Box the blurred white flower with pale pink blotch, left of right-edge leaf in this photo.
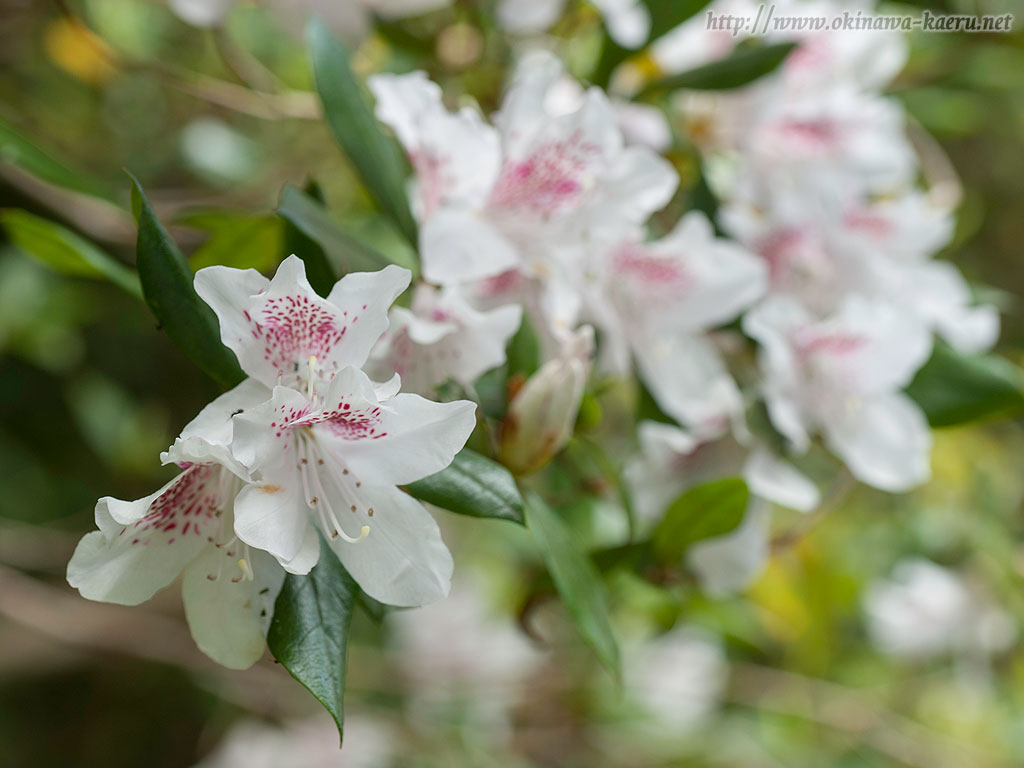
[743,296,932,492]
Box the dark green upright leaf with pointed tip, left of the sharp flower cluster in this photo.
[129,174,245,387]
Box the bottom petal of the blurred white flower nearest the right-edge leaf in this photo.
[824,393,932,493]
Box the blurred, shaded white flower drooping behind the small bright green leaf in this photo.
[626,422,819,596]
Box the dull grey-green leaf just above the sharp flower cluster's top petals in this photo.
[278,186,416,280]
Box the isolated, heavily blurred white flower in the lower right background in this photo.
[863,559,1017,658]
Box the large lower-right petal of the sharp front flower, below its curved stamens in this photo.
[330,485,455,606]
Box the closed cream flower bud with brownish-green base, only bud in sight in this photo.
[500,326,594,475]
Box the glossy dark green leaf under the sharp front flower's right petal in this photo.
[406,449,525,525]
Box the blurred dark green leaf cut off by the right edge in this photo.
[906,343,1024,427]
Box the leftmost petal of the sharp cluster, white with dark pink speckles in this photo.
[68,466,222,605]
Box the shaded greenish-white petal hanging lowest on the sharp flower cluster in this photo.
[181,546,285,670]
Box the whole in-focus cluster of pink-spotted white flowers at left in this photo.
[68,256,476,668]
